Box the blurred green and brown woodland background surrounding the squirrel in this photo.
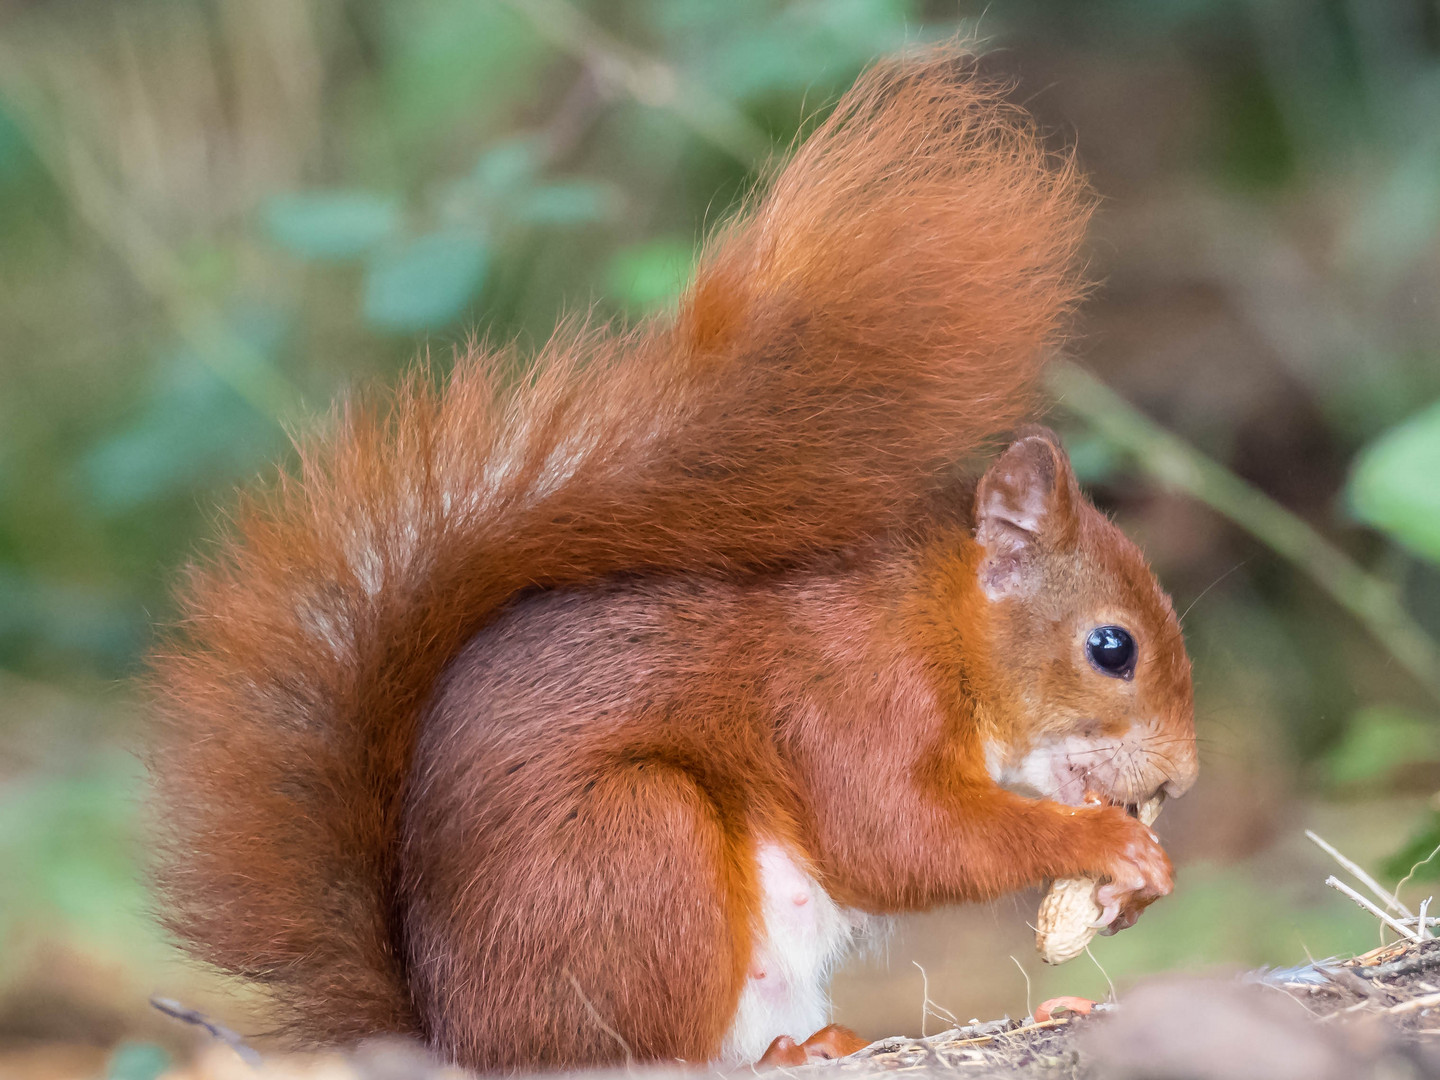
[0,0,1440,1080]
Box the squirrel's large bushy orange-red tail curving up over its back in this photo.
[151,46,1089,1041]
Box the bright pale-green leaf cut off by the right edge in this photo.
[1349,405,1440,562]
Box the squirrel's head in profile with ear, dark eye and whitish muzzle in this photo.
[966,428,1197,805]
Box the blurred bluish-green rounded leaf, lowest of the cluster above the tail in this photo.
[364,230,490,331]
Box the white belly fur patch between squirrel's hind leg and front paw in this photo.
[720,842,868,1066]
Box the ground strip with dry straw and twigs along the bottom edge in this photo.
[137,939,1440,1080]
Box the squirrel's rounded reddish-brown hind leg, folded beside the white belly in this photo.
[409,743,753,1071]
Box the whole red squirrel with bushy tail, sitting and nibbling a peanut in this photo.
[150,45,1195,1070]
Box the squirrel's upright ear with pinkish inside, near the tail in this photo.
[975,426,1081,600]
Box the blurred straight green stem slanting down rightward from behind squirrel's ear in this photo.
[1050,364,1440,700]
